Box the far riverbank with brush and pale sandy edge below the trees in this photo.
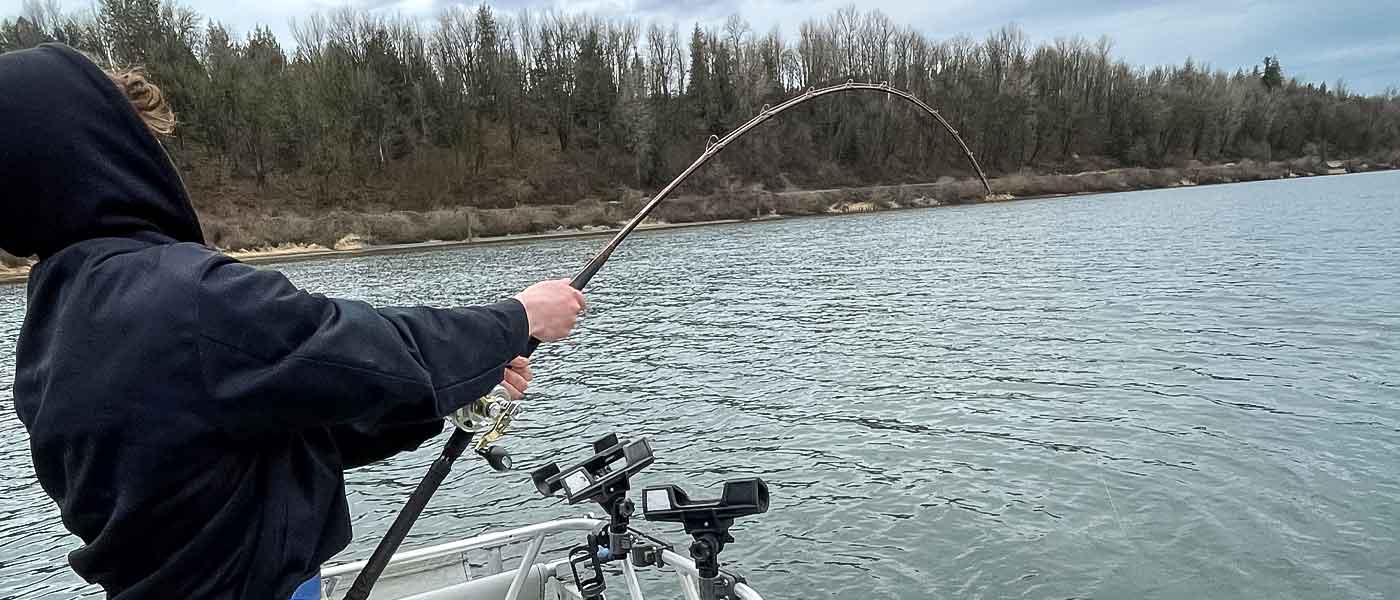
[0,161,1394,284]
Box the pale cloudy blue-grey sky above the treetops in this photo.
[10,0,1400,92]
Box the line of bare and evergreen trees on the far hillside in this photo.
[0,0,1400,210]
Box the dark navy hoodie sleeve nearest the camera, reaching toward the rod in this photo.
[196,256,529,433]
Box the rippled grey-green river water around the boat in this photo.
[0,173,1400,600]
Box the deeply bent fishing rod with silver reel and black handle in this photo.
[344,81,991,600]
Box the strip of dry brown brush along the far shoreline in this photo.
[49,154,1400,254]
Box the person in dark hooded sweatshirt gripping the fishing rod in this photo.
[0,45,582,599]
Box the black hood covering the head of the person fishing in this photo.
[0,43,204,259]
